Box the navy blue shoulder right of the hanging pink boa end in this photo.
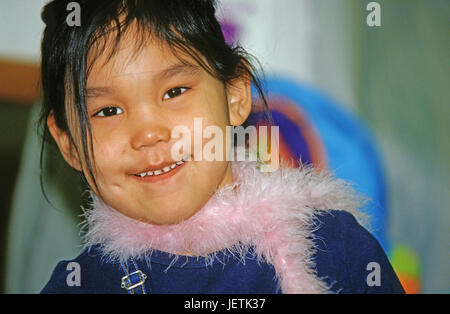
[313,210,404,293]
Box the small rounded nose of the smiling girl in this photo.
[130,115,171,150]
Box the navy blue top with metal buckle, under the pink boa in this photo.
[42,210,404,294]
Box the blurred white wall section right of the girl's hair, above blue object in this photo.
[221,0,358,108]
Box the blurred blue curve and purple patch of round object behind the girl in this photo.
[252,77,390,252]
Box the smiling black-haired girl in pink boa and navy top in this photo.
[41,0,403,294]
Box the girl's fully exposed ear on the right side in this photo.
[226,70,252,126]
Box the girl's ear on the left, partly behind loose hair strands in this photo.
[47,112,82,171]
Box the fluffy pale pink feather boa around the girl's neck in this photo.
[80,162,360,293]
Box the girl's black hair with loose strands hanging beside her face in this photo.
[39,0,271,195]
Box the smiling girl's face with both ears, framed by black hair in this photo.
[48,29,251,225]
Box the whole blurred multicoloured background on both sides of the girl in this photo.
[0,0,450,293]
